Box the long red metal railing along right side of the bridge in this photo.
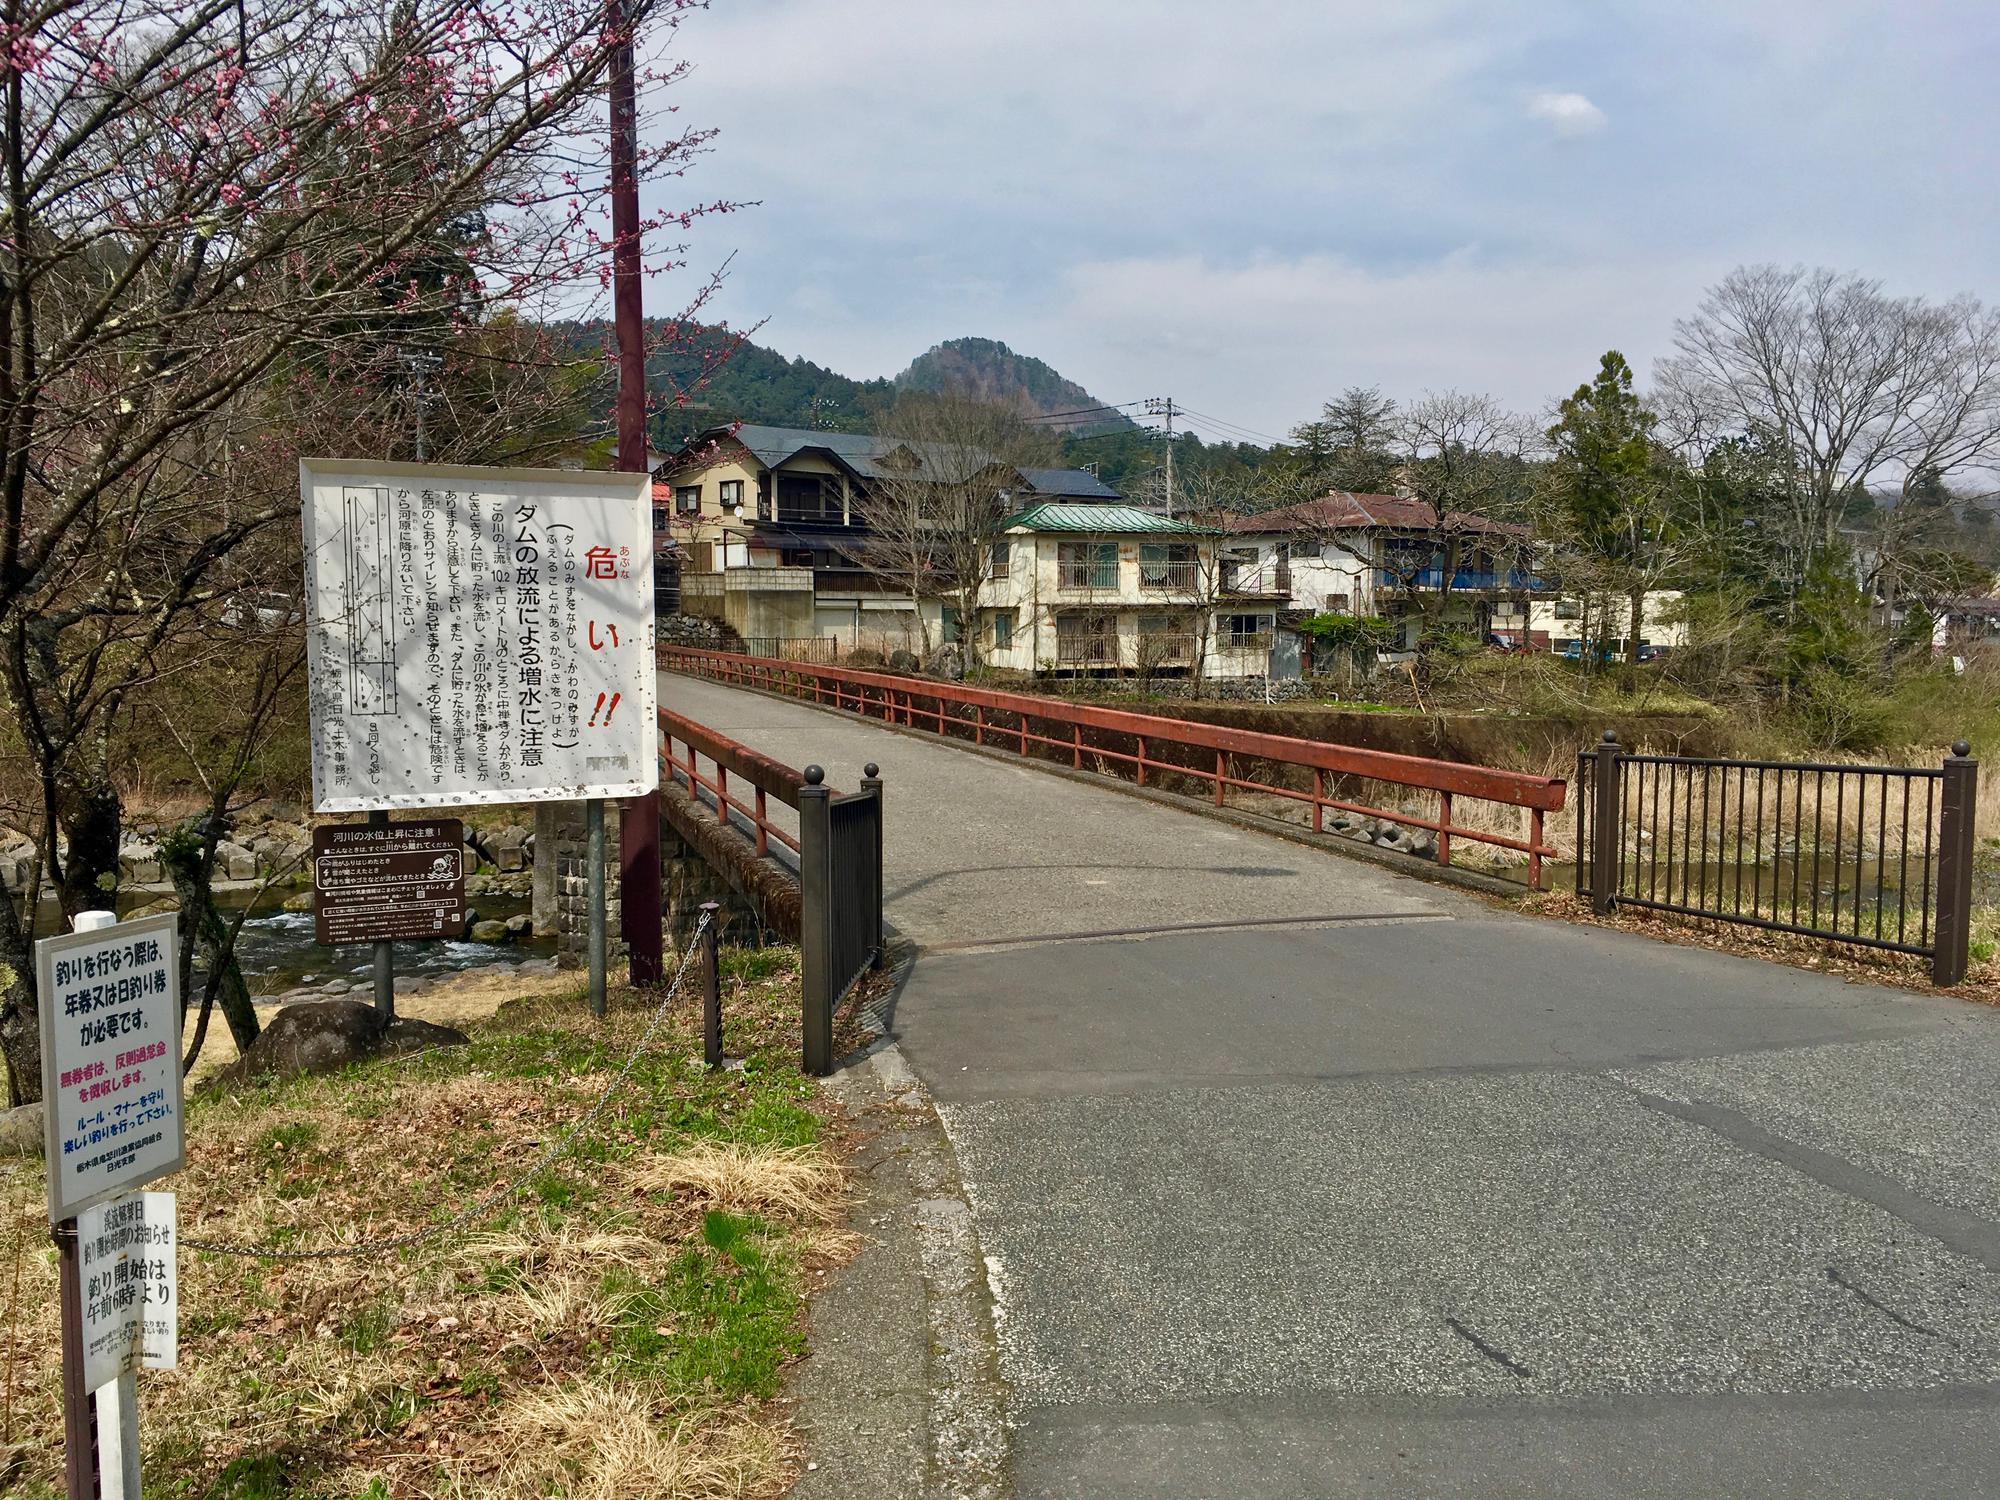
[660,646,1568,890]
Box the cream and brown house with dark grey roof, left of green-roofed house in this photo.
[654,422,1122,648]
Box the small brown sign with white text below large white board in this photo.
[312,818,466,944]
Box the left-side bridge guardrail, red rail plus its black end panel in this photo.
[660,708,882,1076]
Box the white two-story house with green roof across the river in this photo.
[972,500,1284,678]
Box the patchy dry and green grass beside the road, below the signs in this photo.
[0,948,846,1500]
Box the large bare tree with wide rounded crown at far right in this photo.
[1658,266,2000,594]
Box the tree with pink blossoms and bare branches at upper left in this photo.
[0,0,734,1100]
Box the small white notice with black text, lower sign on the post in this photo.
[76,1192,180,1390]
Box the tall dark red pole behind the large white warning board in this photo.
[608,0,664,984]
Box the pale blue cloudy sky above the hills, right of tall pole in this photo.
[650,0,2000,444]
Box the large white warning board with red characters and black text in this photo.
[298,458,658,812]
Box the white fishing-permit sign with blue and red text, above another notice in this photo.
[34,914,188,1224]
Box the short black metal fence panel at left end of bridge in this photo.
[798,766,882,1074]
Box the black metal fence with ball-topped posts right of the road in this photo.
[1576,730,1978,984]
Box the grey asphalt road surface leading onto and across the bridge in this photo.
[660,674,2000,1500]
